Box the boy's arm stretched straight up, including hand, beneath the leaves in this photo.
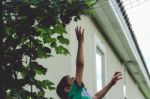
[75,27,84,86]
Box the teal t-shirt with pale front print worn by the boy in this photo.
[68,81,92,99]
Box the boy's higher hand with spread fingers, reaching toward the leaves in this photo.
[75,26,84,42]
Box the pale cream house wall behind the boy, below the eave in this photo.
[39,16,144,99]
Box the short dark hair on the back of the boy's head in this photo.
[56,75,68,99]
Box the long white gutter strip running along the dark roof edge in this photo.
[110,0,150,87]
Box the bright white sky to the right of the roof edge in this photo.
[123,0,150,73]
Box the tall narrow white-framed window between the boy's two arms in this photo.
[95,35,105,91]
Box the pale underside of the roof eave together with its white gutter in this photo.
[95,0,150,99]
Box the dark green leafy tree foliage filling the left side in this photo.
[0,0,93,99]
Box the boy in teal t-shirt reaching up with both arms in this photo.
[56,27,122,99]
